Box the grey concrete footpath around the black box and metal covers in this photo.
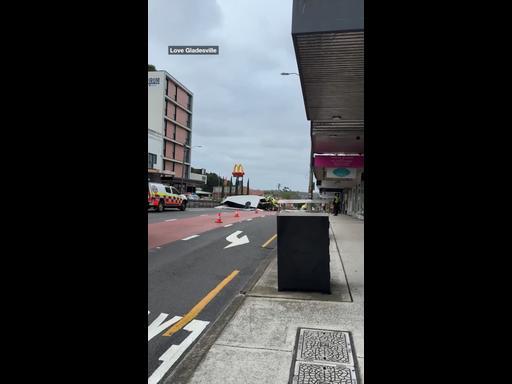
[189,216,364,384]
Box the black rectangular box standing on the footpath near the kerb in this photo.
[277,212,331,293]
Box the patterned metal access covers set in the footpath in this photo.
[290,328,357,384]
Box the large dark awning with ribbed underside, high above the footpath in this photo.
[292,0,364,186]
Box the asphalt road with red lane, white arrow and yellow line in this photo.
[148,208,276,384]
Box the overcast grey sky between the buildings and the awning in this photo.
[148,0,310,191]
